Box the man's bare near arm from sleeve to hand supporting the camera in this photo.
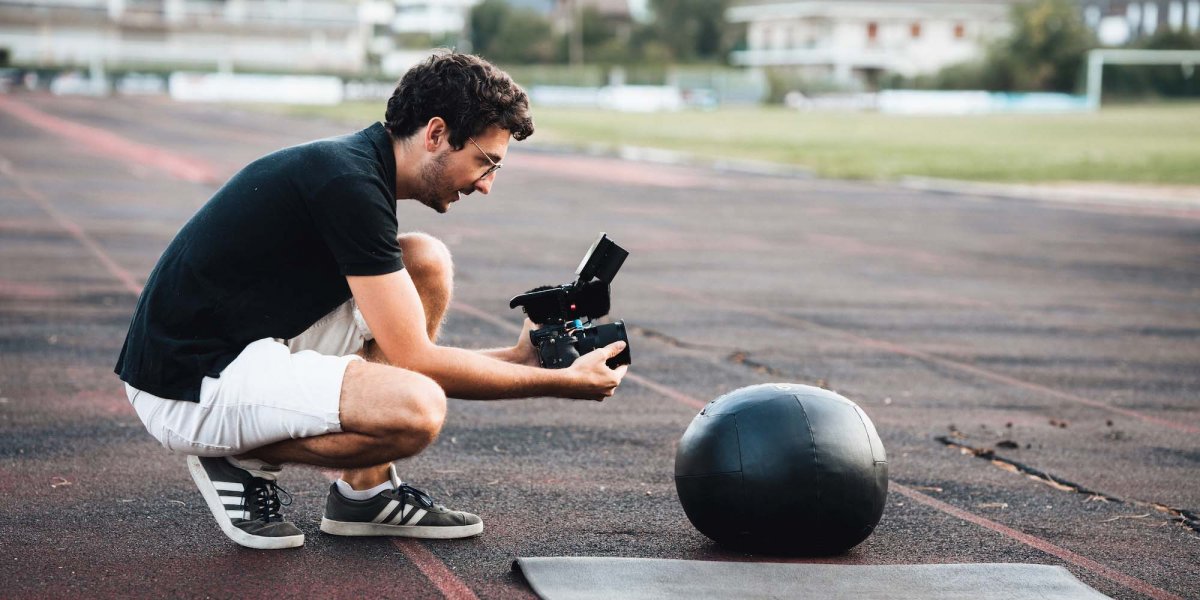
[347,270,628,400]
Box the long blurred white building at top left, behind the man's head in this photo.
[0,0,479,74]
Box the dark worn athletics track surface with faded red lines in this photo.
[0,94,1200,599]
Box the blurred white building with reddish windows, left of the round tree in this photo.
[726,0,1015,85]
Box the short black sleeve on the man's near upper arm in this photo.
[310,174,404,275]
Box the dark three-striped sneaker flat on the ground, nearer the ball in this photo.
[320,467,484,540]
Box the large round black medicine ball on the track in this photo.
[674,384,888,554]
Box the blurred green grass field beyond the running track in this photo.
[270,102,1200,185]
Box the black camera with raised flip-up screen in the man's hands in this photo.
[509,233,630,368]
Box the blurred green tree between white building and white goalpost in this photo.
[979,0,1096,92]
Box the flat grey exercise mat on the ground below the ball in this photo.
[512,557,1109,600]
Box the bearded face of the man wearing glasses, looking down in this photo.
[415,127,510,212]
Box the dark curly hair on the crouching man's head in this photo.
[384,50,533,150]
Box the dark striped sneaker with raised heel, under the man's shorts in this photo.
[187,456,304,550]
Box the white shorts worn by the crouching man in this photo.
[125,300,372,456]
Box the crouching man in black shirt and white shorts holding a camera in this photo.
[115,53,626,548]
